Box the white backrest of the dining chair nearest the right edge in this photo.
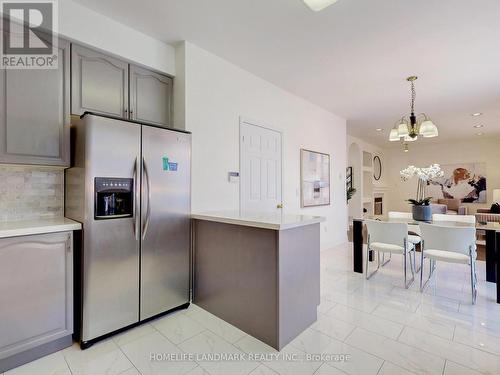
[420,223,476,255]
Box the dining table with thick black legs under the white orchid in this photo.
[352,216,500,304]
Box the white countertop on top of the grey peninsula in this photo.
[191,211,325,230]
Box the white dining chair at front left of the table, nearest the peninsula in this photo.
[365,220,416,289]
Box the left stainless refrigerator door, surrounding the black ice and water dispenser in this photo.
[81,115,141,342]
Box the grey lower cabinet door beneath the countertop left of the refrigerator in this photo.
[0,232,73,360]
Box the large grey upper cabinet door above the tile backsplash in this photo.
[0,36,70,166]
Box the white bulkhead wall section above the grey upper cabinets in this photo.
[58,0,175,75]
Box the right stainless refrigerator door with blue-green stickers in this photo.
[140,126,191,320]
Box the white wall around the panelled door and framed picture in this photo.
[183,43,347,248]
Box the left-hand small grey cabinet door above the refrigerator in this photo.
[71,44,128,118]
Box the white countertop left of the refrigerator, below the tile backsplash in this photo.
[0,217,82,238]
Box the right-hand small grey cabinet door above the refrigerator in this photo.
[130,65,172,127]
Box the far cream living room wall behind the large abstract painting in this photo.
[386,138,500,213]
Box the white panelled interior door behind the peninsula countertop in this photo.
[240,121,282,212]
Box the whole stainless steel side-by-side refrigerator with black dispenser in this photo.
[65,113,191,347]
